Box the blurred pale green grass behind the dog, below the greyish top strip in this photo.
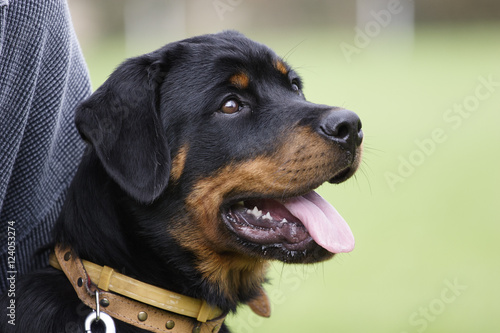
[80,24,500,333]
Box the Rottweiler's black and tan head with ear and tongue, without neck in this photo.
[76,32,363,298]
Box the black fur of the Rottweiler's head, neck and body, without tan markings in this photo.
[0,32,366,333]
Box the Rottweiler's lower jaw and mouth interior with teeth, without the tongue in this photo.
[221,198,334,263]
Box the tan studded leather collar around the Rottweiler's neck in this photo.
[50,244,225,333]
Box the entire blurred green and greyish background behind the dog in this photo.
[69,0,500,333]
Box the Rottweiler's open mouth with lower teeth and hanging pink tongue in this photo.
[222,191,354,253]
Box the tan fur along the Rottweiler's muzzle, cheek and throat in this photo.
[174,127,358,297]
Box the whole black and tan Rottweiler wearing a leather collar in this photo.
[0,31,363,333]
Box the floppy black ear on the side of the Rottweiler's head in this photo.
[75,54,171,203]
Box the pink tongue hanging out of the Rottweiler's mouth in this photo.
[282,191,354,253]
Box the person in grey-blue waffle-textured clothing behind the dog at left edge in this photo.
[0,0,91,294]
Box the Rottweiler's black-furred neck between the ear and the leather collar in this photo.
[55,153,260,311]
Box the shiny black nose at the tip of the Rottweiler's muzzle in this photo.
[319,109,363,150]
